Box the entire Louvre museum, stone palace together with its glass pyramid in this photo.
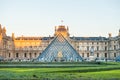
[0,25,120,62]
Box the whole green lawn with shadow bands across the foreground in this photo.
[0,63,120,80]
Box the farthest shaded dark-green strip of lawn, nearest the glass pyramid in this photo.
[0,62,120,68]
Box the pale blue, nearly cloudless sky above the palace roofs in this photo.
[0,0,120,37]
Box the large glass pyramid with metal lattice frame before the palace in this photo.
[37,34,83,62]
